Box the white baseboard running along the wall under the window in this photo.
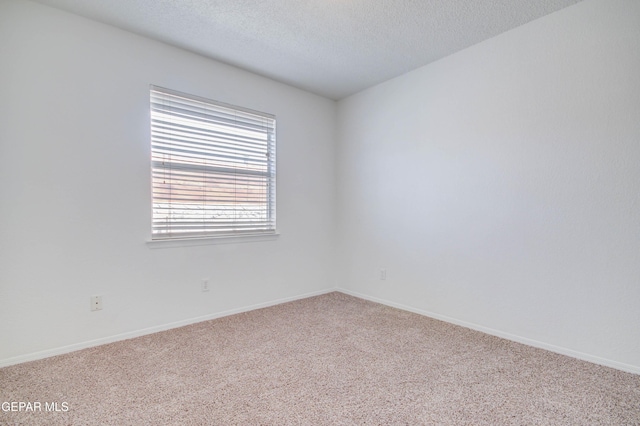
[0,288,338,368]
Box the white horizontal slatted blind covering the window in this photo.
[151,86,276,239]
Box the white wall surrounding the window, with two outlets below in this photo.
[0,0,335,364]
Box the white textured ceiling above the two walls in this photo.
[38,0,581,99]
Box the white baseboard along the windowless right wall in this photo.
[337,288,640,374]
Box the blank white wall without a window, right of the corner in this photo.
[338,0,640,372]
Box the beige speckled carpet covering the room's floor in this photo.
[0,293,640,425]
